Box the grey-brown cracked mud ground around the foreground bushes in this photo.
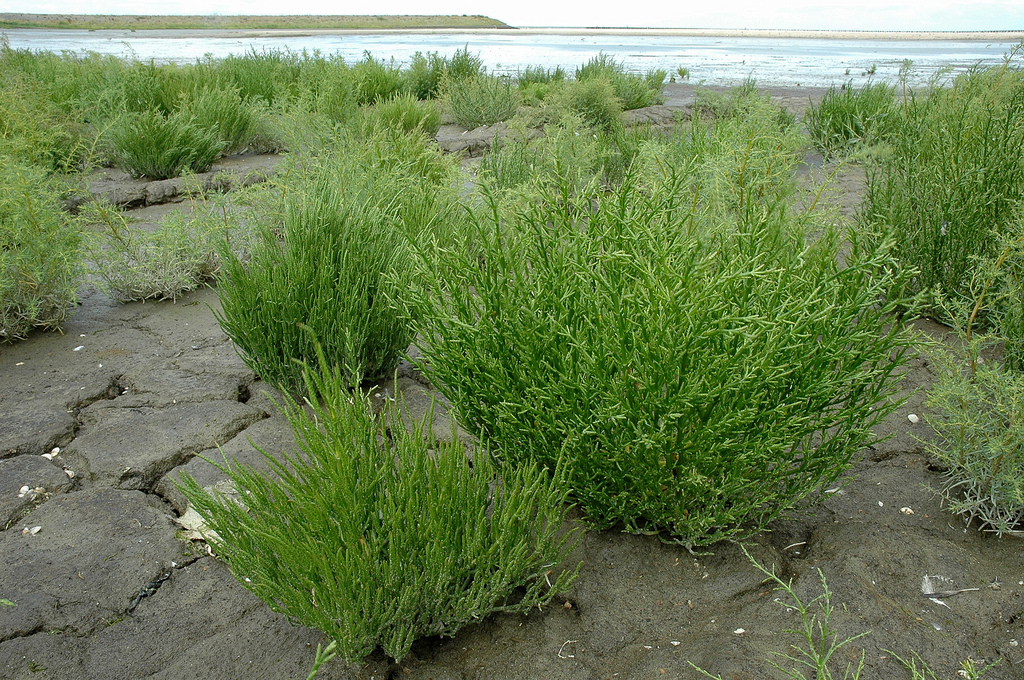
[0,100,1024,680]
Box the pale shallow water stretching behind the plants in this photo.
[4,29,1016,87]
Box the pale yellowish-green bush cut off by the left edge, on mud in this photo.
[0,154,81,342]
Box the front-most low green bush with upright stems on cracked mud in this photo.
[176,353,578,662]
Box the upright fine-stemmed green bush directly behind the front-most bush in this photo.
[217,151,417,388]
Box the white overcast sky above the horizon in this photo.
[0,0,1024,31]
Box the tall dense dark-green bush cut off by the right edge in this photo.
[861,51,1024,321]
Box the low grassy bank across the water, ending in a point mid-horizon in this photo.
[0,13,512,30]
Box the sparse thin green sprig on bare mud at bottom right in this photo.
[690,548,867,680]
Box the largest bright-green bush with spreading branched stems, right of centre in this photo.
[414,99,909,545]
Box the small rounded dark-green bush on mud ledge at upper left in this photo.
[109,110,223,179]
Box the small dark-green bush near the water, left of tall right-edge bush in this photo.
[805,83,899,157]
